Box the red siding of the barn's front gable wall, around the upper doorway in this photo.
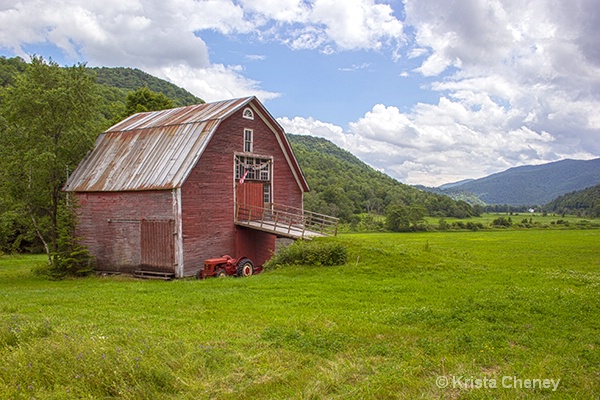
[181,103,302,275]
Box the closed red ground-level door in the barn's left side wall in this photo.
[141,220,175,272]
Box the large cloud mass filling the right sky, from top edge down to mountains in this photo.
[281,0,600,185]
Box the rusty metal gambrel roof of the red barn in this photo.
[64,96,309,192]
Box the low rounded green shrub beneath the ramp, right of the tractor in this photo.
[264,240,348,269]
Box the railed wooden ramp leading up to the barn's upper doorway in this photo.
[235,204,339,240]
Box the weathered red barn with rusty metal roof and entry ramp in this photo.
[64,97,337,277]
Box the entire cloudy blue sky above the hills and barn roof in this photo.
[0,0,600,186]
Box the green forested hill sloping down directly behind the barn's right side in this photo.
[287,134,474,220]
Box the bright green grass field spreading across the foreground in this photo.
[0,230,600,399]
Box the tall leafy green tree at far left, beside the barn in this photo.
[0,57,102,264]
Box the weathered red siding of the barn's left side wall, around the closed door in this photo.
[77,190,175,272]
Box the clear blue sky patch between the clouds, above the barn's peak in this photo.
[202,27,439,126]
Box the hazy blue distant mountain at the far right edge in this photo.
[437,158,600,206]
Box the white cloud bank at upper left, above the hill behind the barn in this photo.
[0,0,264,101]
